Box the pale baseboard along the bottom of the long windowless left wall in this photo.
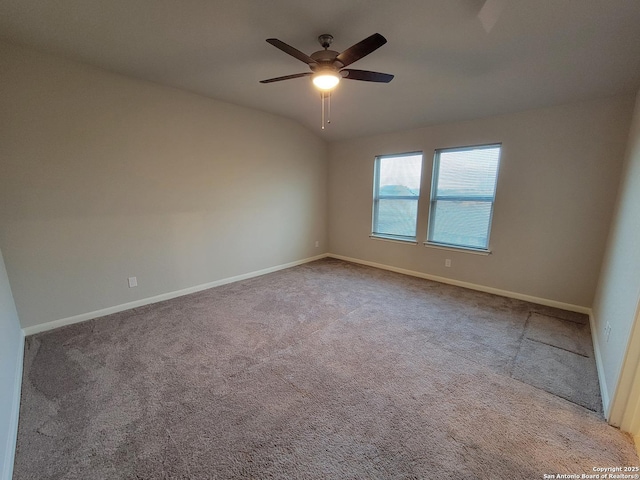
[23,254,327,335]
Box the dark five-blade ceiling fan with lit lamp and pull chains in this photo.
[260,33,393,129]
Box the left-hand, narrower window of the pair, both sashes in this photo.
[372,153,422,242]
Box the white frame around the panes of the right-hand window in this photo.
[424,142,502,255]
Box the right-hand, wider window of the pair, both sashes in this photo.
[427,145,501,251]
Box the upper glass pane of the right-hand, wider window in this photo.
[436,146,500,197]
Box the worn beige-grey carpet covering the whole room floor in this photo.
[14,259,639,479]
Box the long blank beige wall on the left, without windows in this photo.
[0,44,327,327]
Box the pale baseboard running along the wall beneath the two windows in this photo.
[327,253,591,315]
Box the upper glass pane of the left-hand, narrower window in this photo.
[378,155,422,197]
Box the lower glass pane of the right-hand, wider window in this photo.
[429,200,492,248]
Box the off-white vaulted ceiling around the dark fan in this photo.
[0,0,640,140]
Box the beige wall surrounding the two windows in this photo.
[329,96,633,307]
